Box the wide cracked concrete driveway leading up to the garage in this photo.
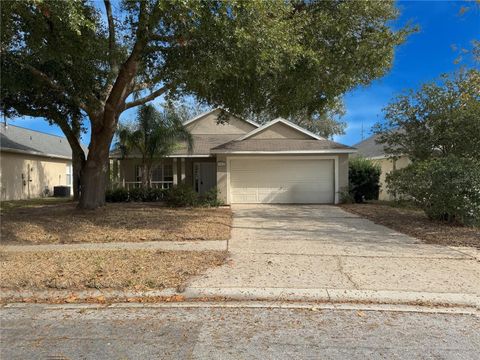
[189,205,480,303]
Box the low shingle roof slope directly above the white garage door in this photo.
[212,139,355,154]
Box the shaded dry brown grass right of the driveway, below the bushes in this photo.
[342,204,480,249]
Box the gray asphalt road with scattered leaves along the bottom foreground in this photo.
[0,305,480,360]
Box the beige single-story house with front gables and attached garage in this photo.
[110,109,356,204]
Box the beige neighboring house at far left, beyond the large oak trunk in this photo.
[0,123,84,200]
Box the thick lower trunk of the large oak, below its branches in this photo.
[78,119,116,209]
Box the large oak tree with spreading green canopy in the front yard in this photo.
[1,0,408,208]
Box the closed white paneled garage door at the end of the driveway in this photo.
[230,159,334,204]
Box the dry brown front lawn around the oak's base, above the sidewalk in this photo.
[1,203,232,244]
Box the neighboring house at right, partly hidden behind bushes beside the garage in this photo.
[354,135,410,200]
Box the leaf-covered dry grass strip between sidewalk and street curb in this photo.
[0,250,226,290]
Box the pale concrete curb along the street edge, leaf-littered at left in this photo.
[0,287,480,309]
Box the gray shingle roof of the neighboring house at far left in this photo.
[0,124,86,159]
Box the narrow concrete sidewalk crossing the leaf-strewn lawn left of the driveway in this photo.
[0,240,227,252]
